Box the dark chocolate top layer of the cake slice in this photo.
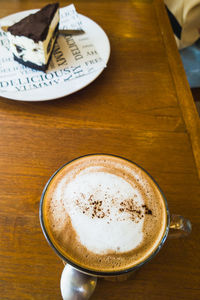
[8,3,59,43]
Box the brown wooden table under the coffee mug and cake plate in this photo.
[0,0,200,300]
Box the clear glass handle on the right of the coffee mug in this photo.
[168,215,192,238]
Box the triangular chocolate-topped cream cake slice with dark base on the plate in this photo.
[7,3,59,71]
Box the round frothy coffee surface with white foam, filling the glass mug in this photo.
[44,156,166,271]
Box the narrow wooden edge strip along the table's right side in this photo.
[154,0,200,179]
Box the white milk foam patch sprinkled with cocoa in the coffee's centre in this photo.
[53,166,145,254]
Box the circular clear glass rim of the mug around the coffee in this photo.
[39,153,170,277]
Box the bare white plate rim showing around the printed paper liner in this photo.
[0,10,110,101]
